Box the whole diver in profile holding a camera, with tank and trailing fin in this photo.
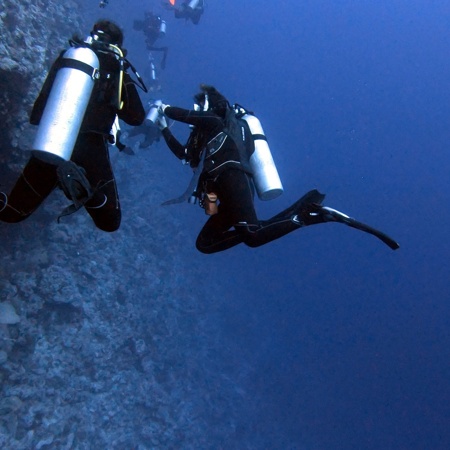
[158,84,399,254]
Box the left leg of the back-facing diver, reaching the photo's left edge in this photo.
[0,156,57,223]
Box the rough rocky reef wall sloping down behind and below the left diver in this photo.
[0,0,264,450]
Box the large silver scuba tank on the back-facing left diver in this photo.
[32,47,100,163]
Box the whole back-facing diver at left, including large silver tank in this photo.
[0,20,146,232]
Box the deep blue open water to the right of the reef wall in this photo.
[3,0,450,449]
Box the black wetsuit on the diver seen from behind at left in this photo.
[0,46,145,231]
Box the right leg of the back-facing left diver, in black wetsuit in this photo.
[72,133,121,232]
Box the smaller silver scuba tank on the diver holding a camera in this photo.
[242,114,283,200]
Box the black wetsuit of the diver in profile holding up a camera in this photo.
[162,106,323,253]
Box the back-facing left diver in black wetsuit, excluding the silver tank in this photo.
[0,20,145,231]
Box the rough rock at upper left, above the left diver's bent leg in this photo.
[0,0,85,163]
